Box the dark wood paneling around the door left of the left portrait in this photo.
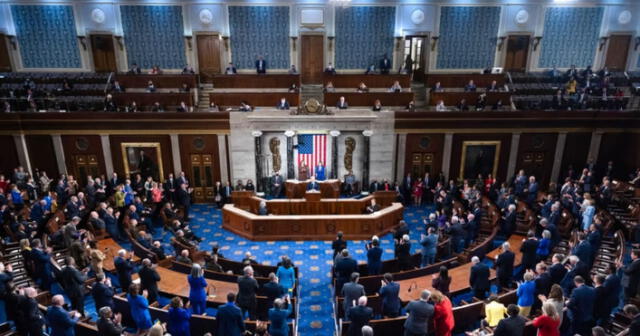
[61,135,106,177]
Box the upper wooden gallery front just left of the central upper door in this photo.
[213,74,300,88]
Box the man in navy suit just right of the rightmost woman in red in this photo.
[567,275,596,336]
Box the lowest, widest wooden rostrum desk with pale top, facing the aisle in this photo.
[222,203,403,241]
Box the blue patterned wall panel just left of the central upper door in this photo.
[229,6,290,69]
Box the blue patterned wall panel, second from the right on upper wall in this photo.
[436,7,500,69]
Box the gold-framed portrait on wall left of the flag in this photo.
[120,142,164,181]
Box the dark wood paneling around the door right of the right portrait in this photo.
[516,133,558,186]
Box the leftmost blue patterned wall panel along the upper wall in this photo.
[11,5,82,68]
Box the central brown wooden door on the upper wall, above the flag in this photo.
[300,35,324,84]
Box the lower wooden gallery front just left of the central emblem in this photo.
[209,92,300,108]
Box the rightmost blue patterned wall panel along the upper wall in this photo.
[538,7,604,68]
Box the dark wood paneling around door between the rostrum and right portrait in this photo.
[403,134,444,179]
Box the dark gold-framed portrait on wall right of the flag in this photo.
[459,141,500,180]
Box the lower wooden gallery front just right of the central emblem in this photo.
[324,89,413,107]
